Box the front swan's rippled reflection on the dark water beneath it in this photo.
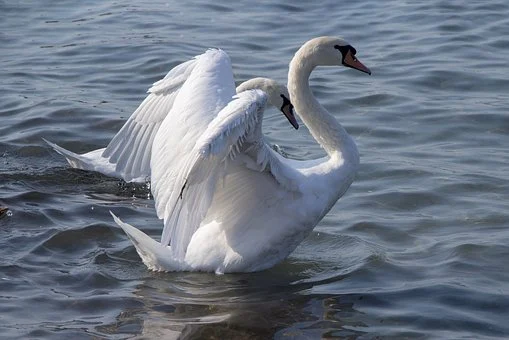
[98,261,367,339]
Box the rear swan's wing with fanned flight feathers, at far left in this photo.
[101,54,203,182]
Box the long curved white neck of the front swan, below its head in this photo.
[288,48,356,157]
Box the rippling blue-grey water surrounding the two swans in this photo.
[0,0,509,339]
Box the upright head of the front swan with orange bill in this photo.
[302,37,371,74]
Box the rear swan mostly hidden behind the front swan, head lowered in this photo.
[43,50,299,183]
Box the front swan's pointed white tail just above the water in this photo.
[110,211,186,271]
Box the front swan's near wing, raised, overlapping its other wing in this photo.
[153,90,267,259]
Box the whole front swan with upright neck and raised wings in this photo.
[112,37,371,273]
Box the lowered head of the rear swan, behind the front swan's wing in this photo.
[237,78,299,129]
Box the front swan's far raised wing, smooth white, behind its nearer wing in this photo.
[151,50,235,255]
